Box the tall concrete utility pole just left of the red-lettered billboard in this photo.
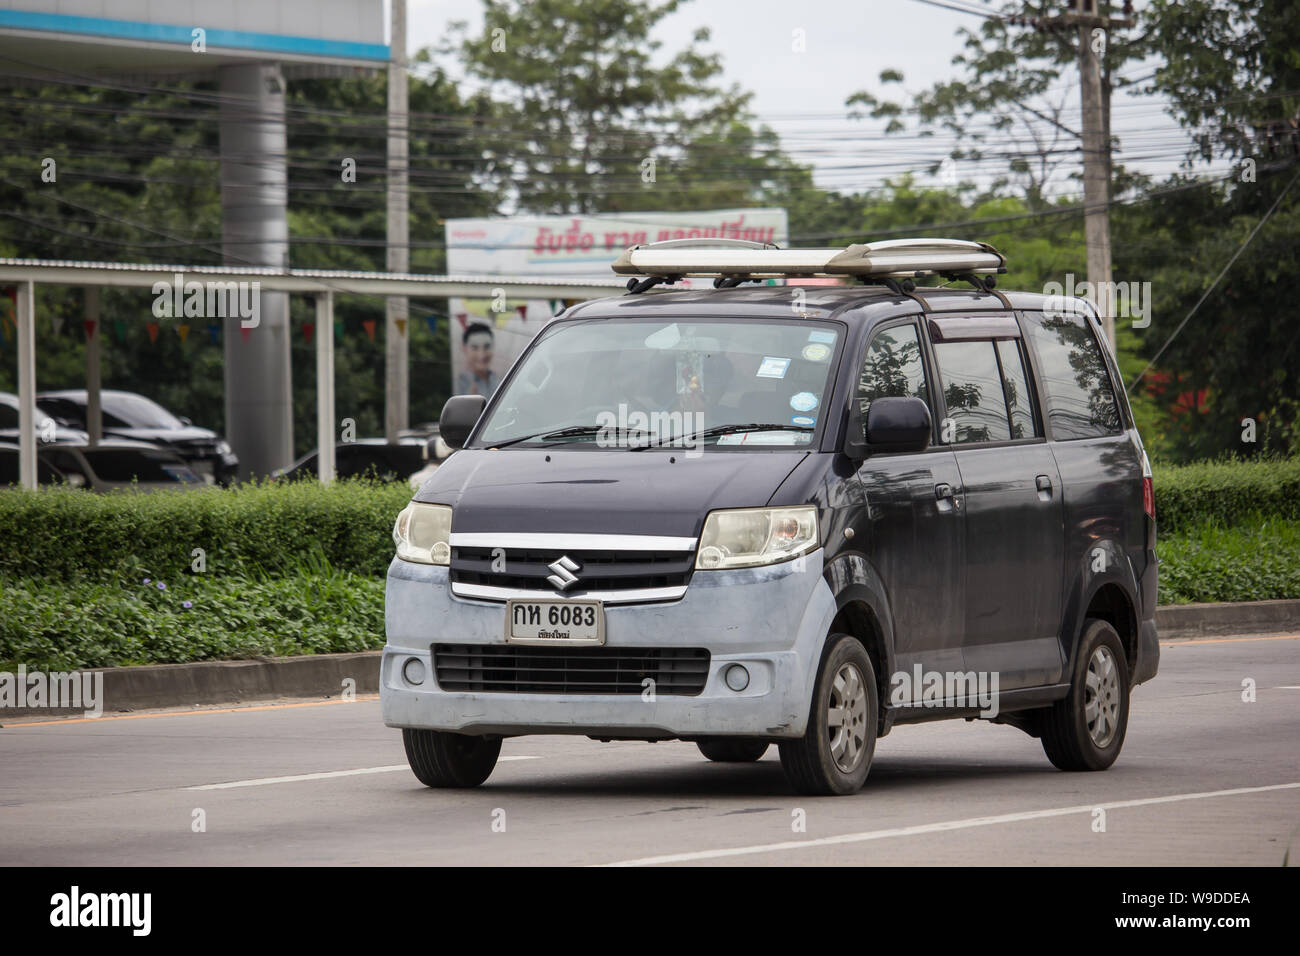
[384,0,411,445]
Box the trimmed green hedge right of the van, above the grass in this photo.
[1153,458,1300,535]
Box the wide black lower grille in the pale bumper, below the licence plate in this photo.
[433,644,709,697]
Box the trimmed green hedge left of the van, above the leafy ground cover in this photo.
[0,481,411,580]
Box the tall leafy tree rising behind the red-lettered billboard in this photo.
[442,0,795,213]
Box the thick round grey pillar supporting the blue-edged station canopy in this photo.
[219,64,294,477]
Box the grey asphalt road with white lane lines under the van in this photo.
[0,636,1300,866]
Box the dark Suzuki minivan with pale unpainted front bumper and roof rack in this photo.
[381,241,1160,793]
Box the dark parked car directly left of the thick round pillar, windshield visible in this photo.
[36,389,239,485]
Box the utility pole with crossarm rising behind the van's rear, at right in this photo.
[1044,0,1132,349]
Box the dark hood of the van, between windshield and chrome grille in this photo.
[415,449,809,537]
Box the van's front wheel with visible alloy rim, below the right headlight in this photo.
[779,633,879,796]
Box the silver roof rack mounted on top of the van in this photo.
[612,239,1006,293]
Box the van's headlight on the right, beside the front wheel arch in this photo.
[696,505,819,571]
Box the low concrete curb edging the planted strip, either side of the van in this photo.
[0,601,1300,718]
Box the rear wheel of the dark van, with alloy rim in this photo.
[1040,618,1130,770]
